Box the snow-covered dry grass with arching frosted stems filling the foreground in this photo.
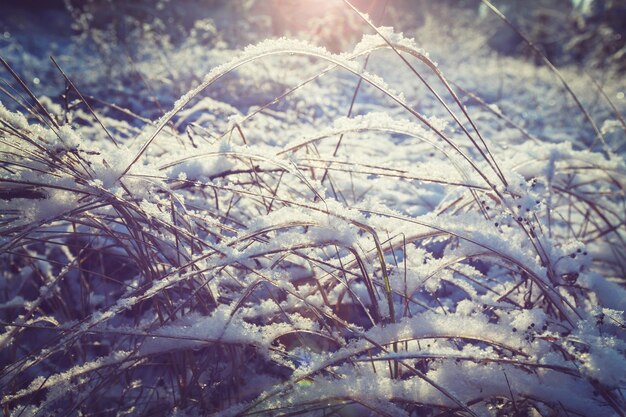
[0,0,626,416]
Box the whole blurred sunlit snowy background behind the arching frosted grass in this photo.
[0,0,626,129]
